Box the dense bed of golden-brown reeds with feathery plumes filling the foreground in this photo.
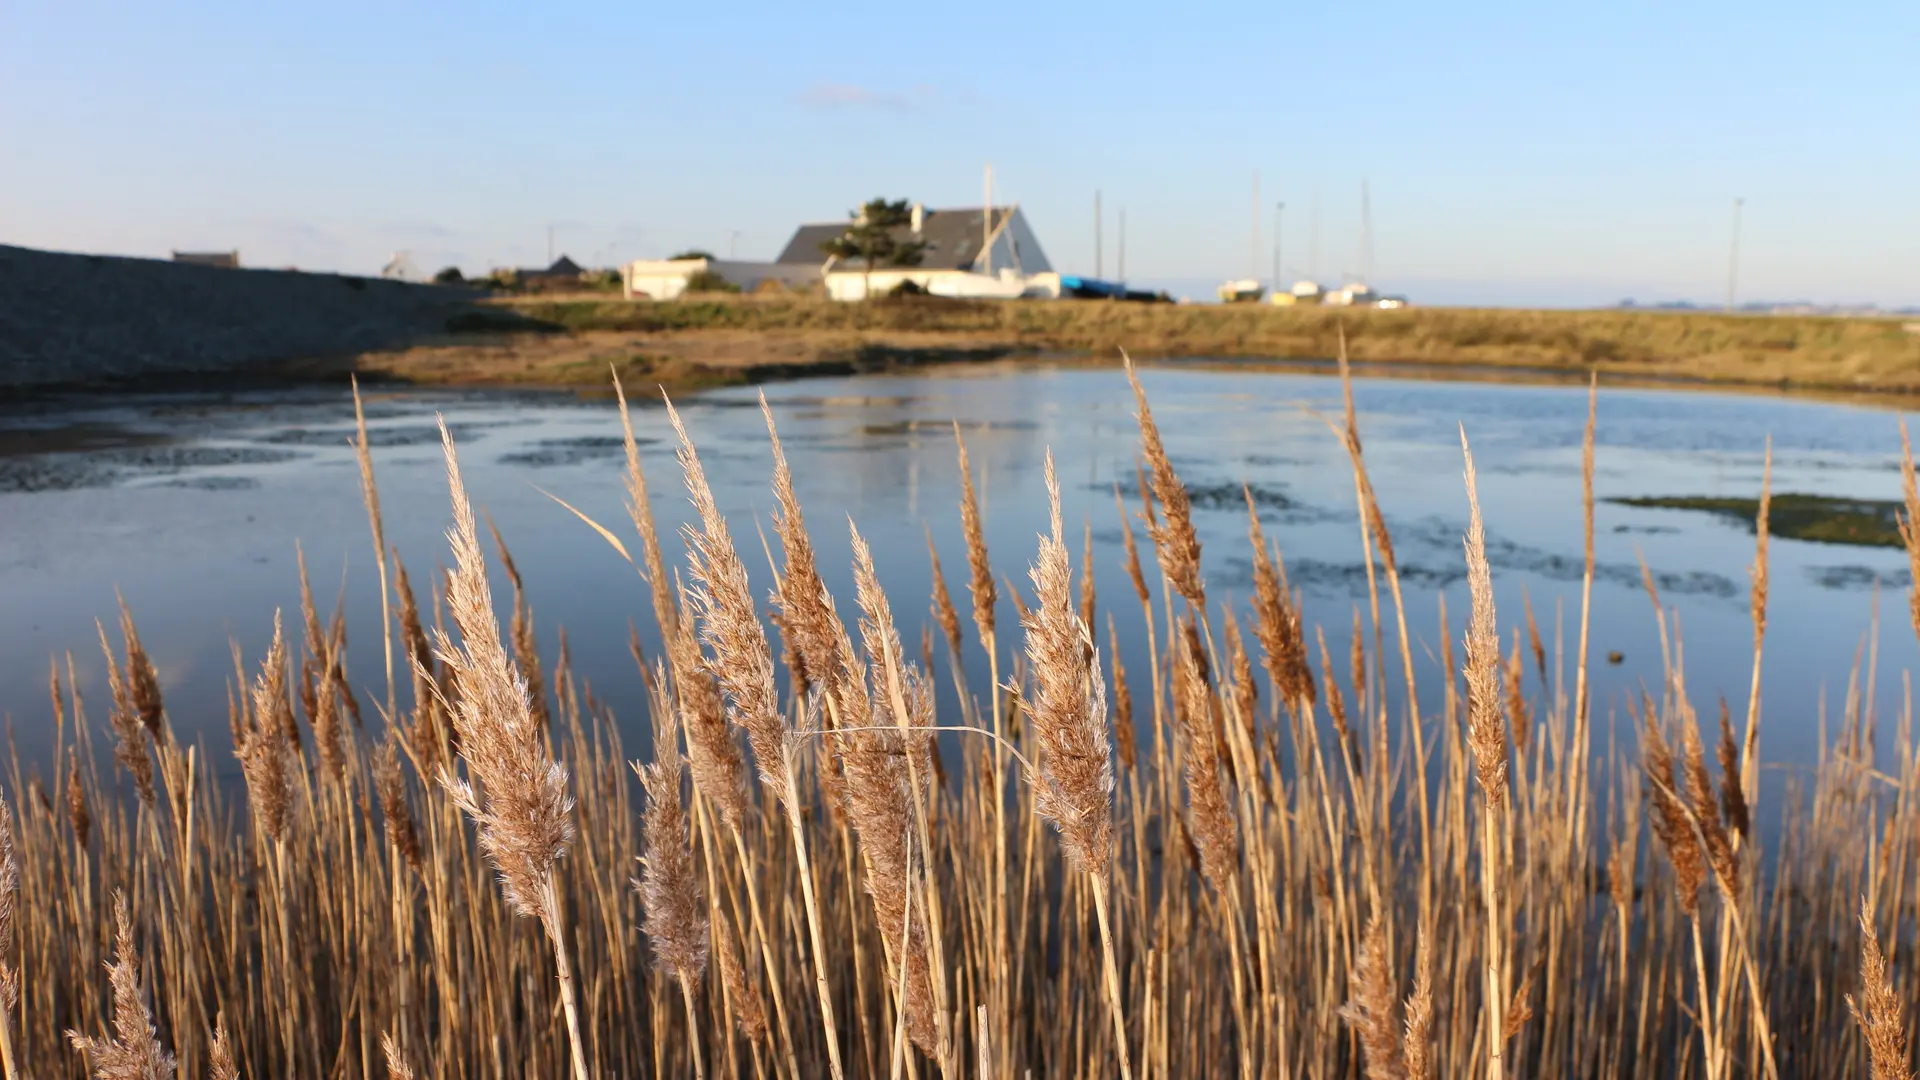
[11,365,1920,1080]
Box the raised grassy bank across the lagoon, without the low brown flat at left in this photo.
[460,296,1920,392]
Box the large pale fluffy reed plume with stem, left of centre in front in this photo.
[436,421,588,1080]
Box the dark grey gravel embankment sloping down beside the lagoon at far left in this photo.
[0,244,474,392]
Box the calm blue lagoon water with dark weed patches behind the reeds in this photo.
[0,363,1914,791]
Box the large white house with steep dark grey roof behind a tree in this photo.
[780,206,1060,300]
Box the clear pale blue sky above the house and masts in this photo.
[0,0,1920,304]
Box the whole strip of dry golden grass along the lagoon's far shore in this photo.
[326,296,1920,394]
